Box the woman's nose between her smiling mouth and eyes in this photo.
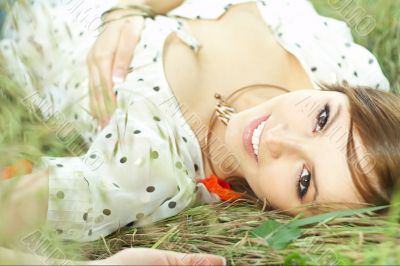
[264,124,307,158]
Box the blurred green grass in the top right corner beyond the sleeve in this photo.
[311,0,400,92]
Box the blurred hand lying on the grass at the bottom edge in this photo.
[89,248,226,265]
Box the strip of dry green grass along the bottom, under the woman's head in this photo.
[77,202,400,265]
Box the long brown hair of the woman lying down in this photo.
[227,84,400,211]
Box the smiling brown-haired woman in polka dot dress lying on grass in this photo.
[1,0,400,264]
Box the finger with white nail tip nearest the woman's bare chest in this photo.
[112,17,144,85]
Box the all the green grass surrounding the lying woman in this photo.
[0,0,400,265]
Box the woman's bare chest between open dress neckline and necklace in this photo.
[164,3,312,122]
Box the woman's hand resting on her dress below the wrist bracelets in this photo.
[86,10,144,127]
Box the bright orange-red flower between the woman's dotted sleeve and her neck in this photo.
[200,175,241,201]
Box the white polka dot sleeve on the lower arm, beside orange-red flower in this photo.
[45,91,198,241]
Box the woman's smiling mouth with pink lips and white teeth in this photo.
[243,115,269,162]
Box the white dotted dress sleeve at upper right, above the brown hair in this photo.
[253,0,390,91]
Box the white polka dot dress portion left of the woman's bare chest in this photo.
[2,2,220,241]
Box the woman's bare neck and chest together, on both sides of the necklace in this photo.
[164,3,311,179]
